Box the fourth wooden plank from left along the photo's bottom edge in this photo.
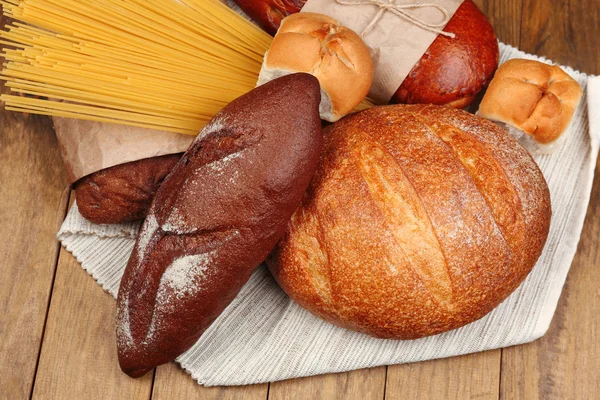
[269,367,386,400]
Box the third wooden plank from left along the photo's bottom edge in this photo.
[152,363,269,400]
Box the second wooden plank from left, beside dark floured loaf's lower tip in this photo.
[33,244,153,400]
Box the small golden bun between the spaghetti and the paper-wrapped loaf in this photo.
[258,12,373,122]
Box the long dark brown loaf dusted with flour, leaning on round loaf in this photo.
[117,74,322,377]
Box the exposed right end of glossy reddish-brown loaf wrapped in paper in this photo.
[391,0,500,108]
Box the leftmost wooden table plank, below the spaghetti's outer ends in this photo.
[0,7,68,399]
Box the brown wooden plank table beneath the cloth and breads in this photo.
[0,0,600,400]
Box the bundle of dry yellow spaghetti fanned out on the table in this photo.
[0,0,271,135]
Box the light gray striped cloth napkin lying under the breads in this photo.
[58,44,600,386]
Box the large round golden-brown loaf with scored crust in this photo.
[268,105,551,339]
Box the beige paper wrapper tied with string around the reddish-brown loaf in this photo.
[302,0,463,104]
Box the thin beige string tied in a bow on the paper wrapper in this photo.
[335,0,456,38]
